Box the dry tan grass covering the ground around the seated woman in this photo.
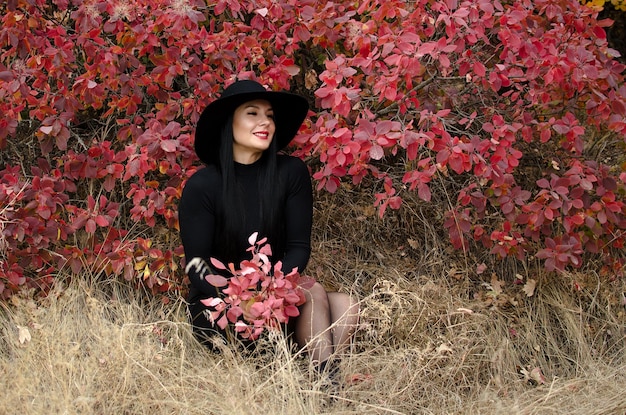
[0,190,626,415]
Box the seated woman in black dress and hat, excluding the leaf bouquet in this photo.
[179,80,358,370]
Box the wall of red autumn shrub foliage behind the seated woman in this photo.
[0,0,626,298]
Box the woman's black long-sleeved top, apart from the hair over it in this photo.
[178,155,313,303]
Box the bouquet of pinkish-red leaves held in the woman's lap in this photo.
[190,232,313,340]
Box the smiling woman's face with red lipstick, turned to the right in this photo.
[233,99,276,164]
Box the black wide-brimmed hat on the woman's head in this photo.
[194,80,309,164]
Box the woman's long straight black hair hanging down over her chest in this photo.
[214,114,285,264]
